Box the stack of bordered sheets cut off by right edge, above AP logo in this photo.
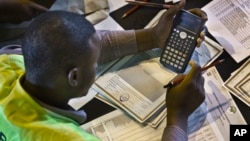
[224,59,250,106]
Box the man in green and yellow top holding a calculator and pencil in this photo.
[0,0,205,141]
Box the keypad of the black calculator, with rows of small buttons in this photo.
[161,28,196,72]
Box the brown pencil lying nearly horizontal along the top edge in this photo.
[126,0,173,9]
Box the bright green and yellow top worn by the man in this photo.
[0,54,99,141]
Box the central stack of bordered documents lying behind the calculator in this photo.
[93,5,223,126]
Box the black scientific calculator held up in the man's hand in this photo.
[160,10,206,73]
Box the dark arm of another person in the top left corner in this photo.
[0,0,48,23]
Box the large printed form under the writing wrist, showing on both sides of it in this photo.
[81,67,246,141]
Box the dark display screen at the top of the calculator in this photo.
[176,12,203,33]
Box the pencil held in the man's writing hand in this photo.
[163,59,225,88]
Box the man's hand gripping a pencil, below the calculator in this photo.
[166,61,205,131]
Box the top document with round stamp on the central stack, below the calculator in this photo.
[95,58,176,123]
